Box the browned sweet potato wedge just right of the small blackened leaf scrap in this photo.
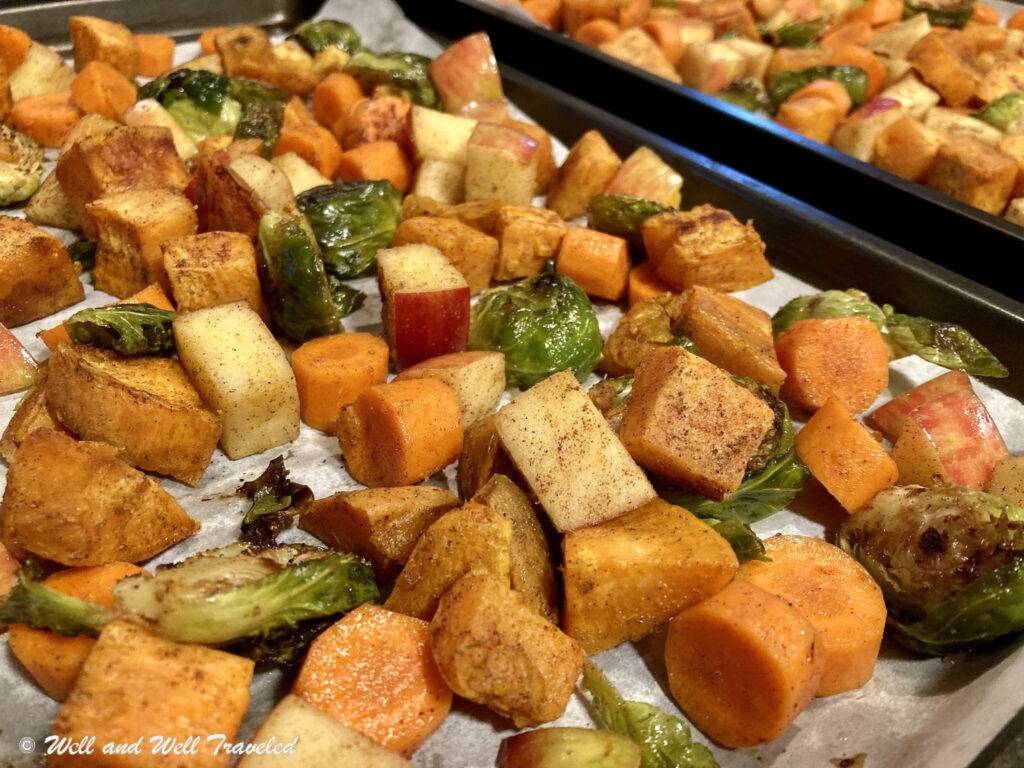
[299,485,459,581]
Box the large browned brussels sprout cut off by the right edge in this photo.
[838,485,1024,653]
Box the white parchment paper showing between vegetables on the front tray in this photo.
[0,0,1024,768]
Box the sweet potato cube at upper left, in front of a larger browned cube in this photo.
[85,189,198,298]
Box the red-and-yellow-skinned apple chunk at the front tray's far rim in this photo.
[429,32,505,114]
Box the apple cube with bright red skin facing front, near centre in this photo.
[377,244,469,371]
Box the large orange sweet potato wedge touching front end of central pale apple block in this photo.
[562,499,738,654]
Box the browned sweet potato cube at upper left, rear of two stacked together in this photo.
[56,126,188,240]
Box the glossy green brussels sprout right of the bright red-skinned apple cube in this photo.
[469,271,602,389]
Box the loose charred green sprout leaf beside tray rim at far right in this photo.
[883,304,1010,379]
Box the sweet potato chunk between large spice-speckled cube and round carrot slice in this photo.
[676,286,785,392]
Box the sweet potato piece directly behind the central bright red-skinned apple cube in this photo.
[391,216,498,294]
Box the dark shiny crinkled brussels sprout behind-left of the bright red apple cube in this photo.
[295,180,401,278]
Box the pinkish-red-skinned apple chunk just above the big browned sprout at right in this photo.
[893,389,1009,490]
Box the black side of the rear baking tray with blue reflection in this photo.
[399,0,1024,299]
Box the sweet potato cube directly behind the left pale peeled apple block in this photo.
[161,232,270,321]
